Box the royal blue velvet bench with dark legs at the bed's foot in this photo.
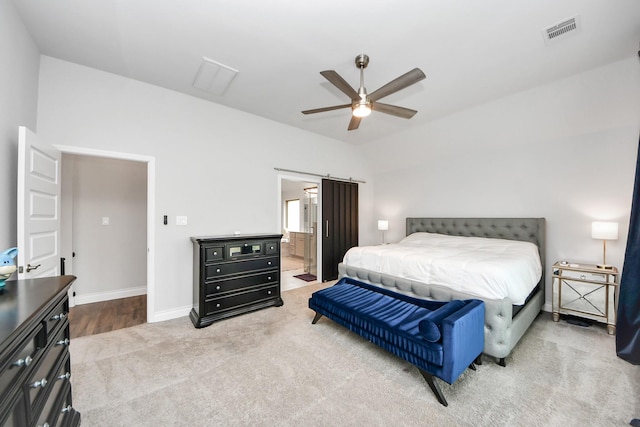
[309,277,484,406]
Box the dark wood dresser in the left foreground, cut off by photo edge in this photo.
[0,276,80,427]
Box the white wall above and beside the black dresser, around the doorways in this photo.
[37,56,375,320]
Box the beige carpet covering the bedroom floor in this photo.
[71,284,640,427]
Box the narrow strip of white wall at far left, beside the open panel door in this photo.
[0,0,40,251]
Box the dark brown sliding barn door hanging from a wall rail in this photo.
[321,179,358,281]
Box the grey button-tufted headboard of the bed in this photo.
[407,218,545,283]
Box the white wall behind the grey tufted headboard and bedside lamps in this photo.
[365,56,640,310]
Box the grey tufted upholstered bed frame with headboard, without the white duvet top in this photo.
[338,218,545,366]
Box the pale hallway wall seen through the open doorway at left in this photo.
[62,154,147,304]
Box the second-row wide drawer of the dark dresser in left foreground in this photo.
[24,324,69,411]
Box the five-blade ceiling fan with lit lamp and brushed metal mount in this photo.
[302,54,426,130]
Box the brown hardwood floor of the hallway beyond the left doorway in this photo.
[69,295,147,339]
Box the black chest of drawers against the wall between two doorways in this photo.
[189,234,282,328]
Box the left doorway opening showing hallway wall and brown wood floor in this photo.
[61,153,147,336]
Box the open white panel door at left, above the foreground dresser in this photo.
[17,126,62,279]
